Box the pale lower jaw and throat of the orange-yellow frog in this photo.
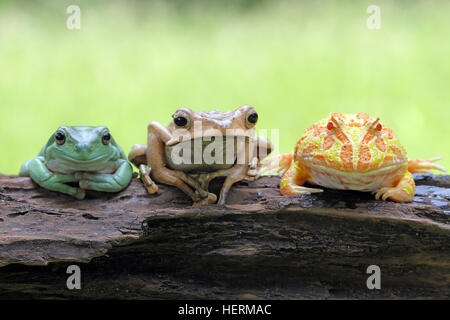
[305,166,407,191]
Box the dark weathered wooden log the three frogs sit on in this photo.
[0,174,450,299]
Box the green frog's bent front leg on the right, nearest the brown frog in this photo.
[75,160,133,192]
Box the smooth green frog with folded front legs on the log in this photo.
[19,126,133,199]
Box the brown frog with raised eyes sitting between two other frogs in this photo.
[128,105,272,206]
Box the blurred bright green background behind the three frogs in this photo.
[0,0,450,174]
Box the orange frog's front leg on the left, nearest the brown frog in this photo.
[280,161,323,196]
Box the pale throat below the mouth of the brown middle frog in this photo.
[165,136,248,172]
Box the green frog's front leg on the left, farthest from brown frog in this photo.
[20,157,86,199]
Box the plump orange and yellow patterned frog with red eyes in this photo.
[261,113,445,202]
